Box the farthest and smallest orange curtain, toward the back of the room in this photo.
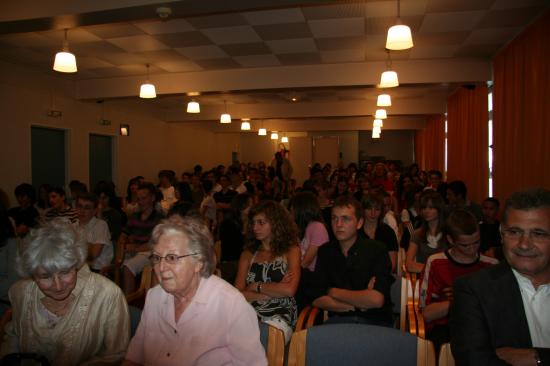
[414,115,445,172]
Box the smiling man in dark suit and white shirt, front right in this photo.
[450,189,550,365]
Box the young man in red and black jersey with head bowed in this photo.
[420,209,498,352]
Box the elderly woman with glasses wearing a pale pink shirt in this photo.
[124,215,267,365]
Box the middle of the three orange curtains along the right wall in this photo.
[447,86,489,203]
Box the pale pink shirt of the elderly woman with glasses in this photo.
[126,275,267,366]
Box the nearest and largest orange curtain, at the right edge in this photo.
[493,11,550,200]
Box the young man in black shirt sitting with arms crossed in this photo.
[311,196,393,326]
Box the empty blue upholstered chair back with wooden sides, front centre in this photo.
[288,324,435,366]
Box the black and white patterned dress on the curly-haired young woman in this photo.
[246,253,297,338]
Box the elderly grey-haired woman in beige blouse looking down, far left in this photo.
[0,221,130,365]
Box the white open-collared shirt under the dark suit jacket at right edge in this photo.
[512,268,550,348]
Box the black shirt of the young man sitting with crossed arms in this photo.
[311,235,394,325]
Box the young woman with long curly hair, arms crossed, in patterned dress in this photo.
[235,201,300,342]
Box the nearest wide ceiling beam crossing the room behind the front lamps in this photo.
[75,59,491,99]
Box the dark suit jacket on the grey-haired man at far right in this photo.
[450,263,550,365]
